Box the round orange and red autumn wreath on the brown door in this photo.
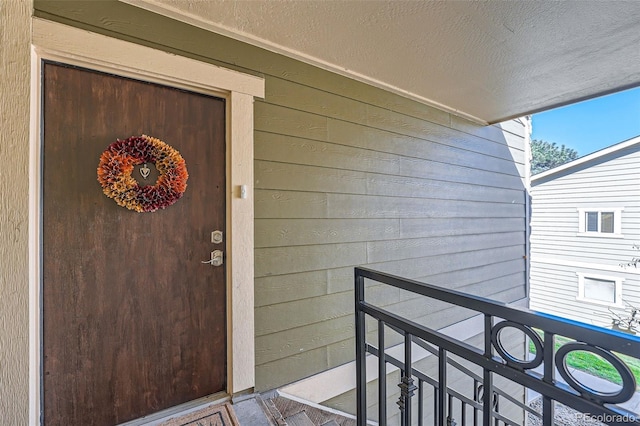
[98,135,189,212]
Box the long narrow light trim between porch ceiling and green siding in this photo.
[119,0,489,126]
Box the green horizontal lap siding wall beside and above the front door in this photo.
[35,1,526,390]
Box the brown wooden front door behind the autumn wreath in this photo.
[42,63,227,426]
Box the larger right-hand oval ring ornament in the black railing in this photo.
[555,342,636,404]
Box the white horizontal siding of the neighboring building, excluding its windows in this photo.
[530,144,640,326]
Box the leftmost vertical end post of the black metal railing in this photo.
[354,269,367,426]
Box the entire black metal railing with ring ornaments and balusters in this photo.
[355,268,640,426]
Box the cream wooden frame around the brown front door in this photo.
[29,18,264,425]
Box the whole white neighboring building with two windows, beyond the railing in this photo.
[530,136,640,327]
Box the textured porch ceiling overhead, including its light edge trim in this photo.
[123,0,640,123]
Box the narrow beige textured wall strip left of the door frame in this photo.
[0,0,32,425]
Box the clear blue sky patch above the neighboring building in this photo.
[531,88,640,157]
